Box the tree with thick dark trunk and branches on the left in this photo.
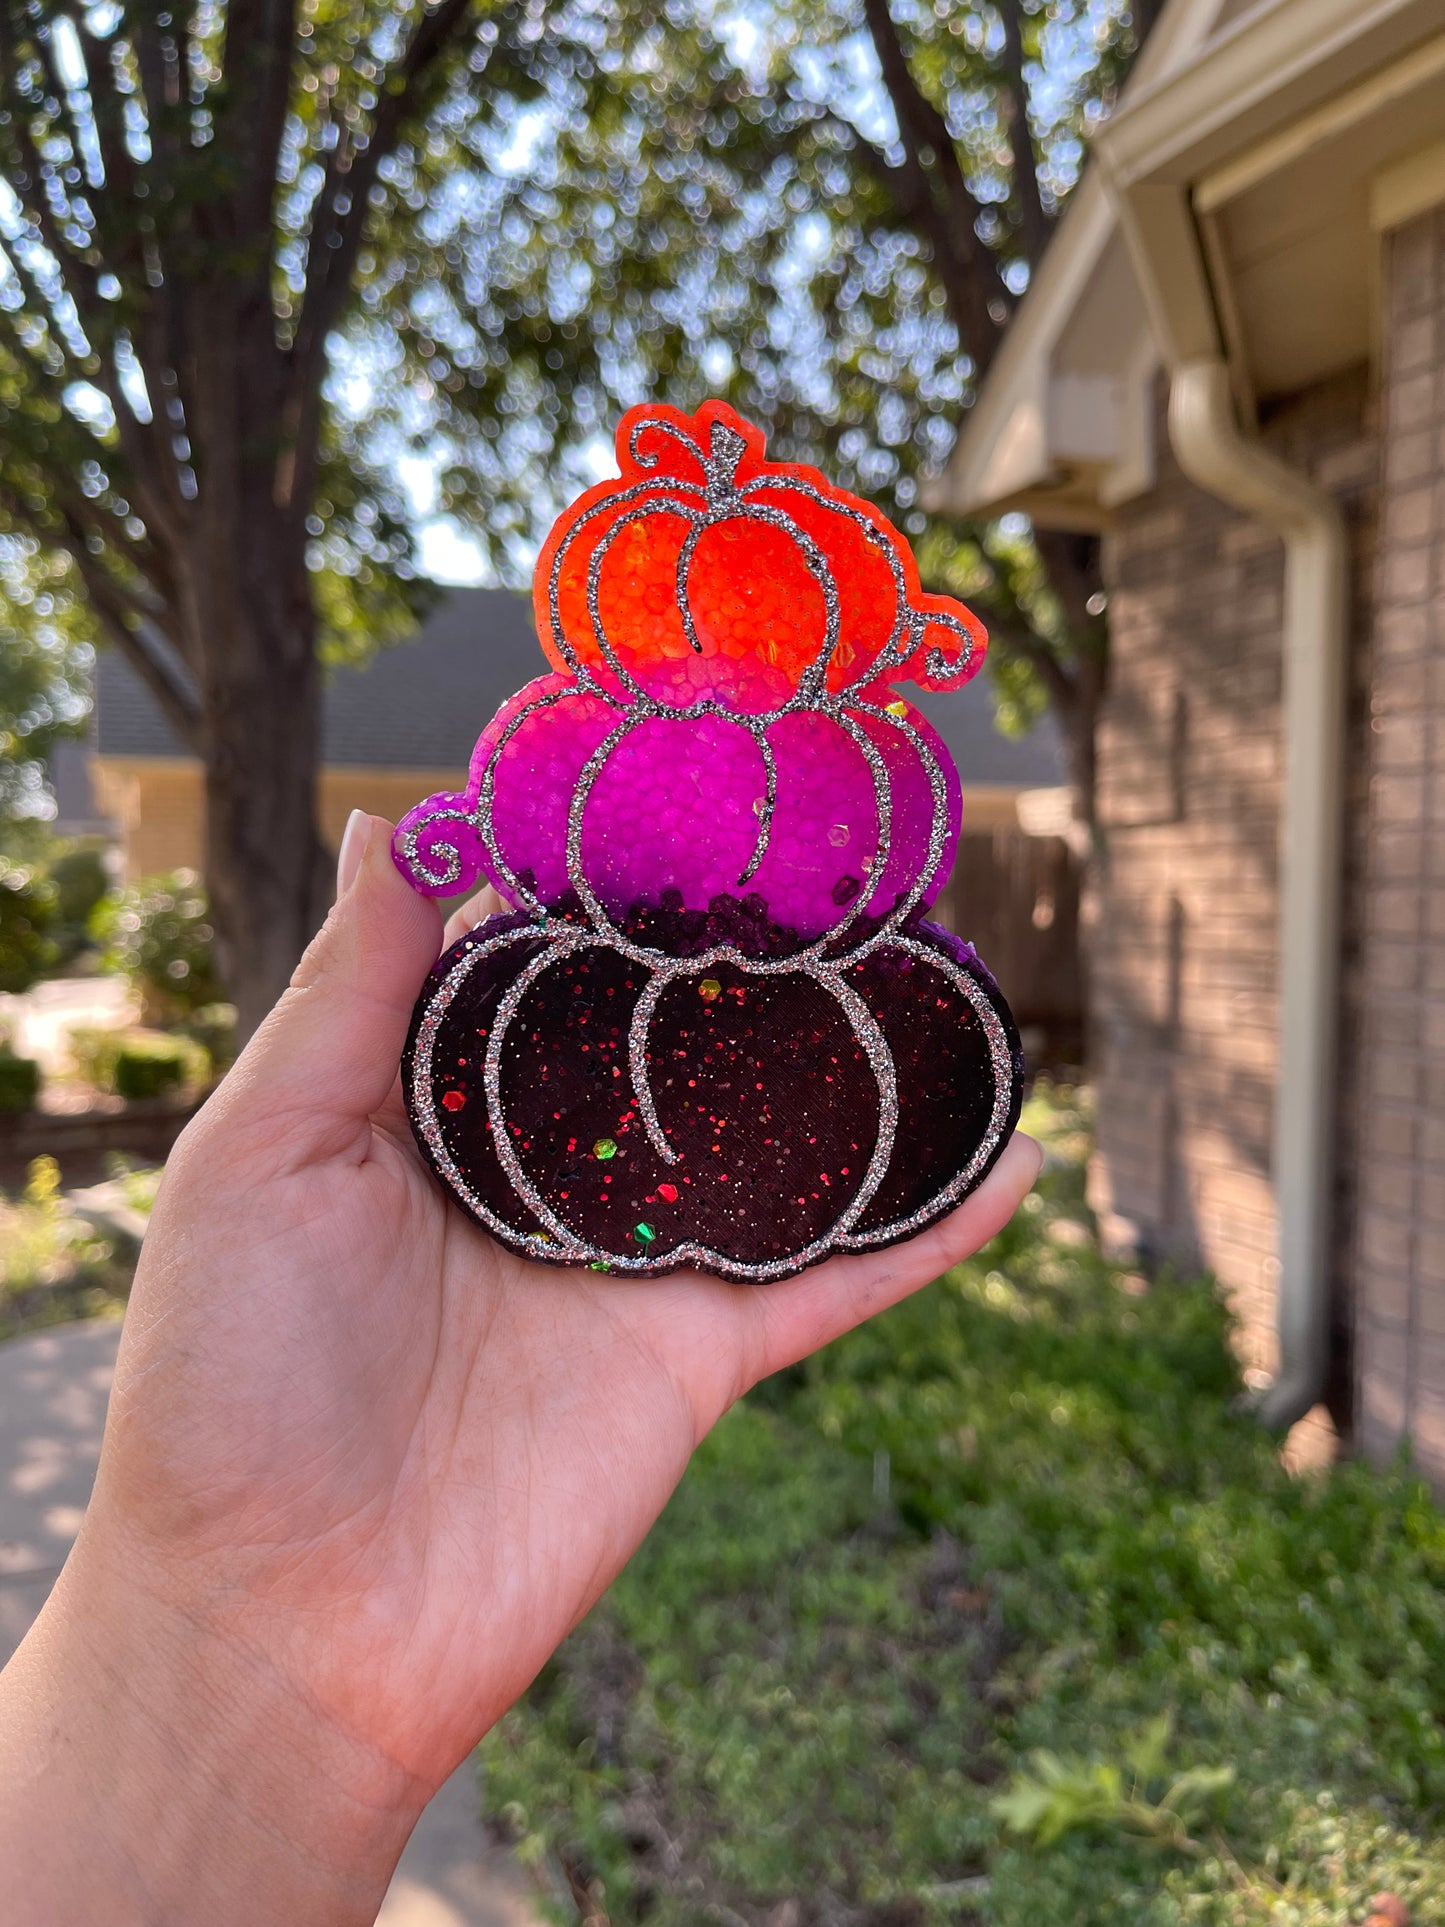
[0,0,549,1025]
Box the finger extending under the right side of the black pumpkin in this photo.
[740,1131,1044,1389]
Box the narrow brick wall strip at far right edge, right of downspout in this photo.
[1354,210,1445,1484]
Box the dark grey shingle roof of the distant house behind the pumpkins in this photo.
[96,588,1065,790]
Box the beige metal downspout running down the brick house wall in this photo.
[1169,355,1349,1430]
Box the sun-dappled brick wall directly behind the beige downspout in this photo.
[1087,370,1378,1403]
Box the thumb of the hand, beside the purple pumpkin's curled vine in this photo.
[208,811,441,1162]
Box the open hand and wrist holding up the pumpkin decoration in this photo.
[0,817,1040,1927]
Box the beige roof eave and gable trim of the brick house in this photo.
[929,0,1445,528]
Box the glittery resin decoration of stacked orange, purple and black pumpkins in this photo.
[395,403,1023,1281]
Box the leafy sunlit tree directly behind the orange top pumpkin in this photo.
[351,0,1152,825]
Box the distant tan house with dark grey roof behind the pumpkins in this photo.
[92,590,1064,877]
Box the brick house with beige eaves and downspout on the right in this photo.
[934,0,1445,1482]
